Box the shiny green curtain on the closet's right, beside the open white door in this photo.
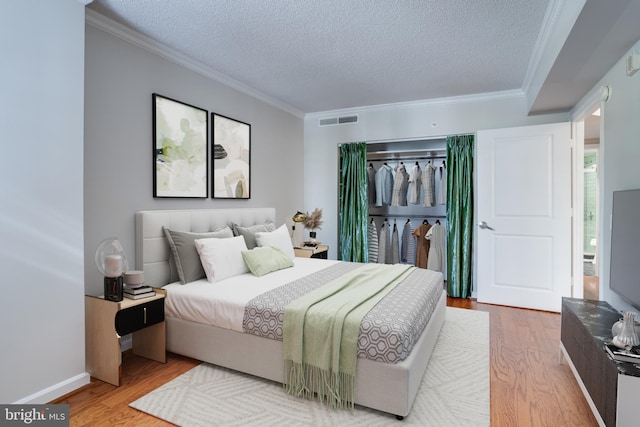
[447,135,474,298]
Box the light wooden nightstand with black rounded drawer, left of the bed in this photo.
[85,289,167,386]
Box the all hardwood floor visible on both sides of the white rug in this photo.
[53,298,597,427]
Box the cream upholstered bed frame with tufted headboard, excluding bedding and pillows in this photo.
[135,208,446,419]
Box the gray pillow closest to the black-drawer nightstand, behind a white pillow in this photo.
[163,227,233,285]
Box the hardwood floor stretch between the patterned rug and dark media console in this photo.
[447,298,598,427]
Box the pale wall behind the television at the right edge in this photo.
[581,41,640,311]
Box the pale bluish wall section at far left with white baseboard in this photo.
[0,0,89,403]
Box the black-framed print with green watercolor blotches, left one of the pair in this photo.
[153,93,209,198]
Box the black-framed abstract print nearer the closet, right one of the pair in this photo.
[211,113,251,199]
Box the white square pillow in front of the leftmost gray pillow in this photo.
[195,236,249,282]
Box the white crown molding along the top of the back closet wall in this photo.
[304,89,524,119]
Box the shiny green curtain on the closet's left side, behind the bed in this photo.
[338,142,369,262]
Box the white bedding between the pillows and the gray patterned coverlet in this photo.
[164,258,339,332]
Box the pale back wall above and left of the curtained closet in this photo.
[304,92,569,258]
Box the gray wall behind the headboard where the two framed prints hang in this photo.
[84,24,305,295]
